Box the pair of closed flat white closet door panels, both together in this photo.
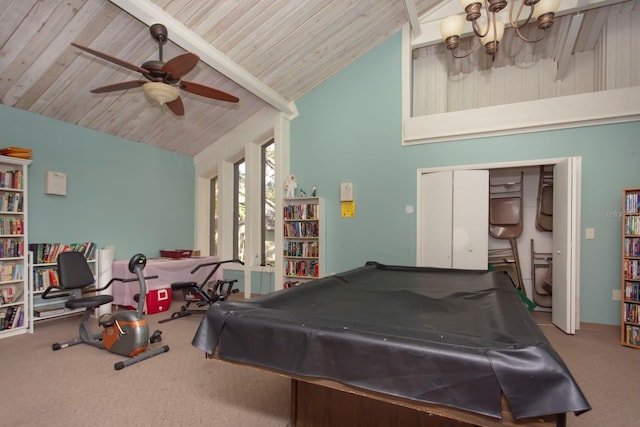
[418,170,489,270]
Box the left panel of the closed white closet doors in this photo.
[419,171,453,268]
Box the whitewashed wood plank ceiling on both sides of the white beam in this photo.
[0,0,438,156]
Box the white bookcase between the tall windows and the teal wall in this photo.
[283,197,326,288]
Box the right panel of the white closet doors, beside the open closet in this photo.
[451,170,489,270]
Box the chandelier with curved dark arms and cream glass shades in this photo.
[440,0,560,58]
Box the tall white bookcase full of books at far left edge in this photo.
[0,156,31,338]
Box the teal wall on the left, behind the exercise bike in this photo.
[0,105,195,259]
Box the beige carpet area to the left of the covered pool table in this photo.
[0,305,290,427]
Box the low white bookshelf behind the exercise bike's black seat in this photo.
[29,242,99,324]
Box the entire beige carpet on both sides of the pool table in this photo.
[0,302,640,427]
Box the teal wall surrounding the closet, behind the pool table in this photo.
[291,34,640,324]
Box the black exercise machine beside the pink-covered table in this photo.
[158,259,244,323]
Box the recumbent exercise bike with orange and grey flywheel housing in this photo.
[42,252,169,370]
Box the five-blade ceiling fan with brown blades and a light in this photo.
[71,24,239,116]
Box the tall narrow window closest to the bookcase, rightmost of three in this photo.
[260,140,276,265]
